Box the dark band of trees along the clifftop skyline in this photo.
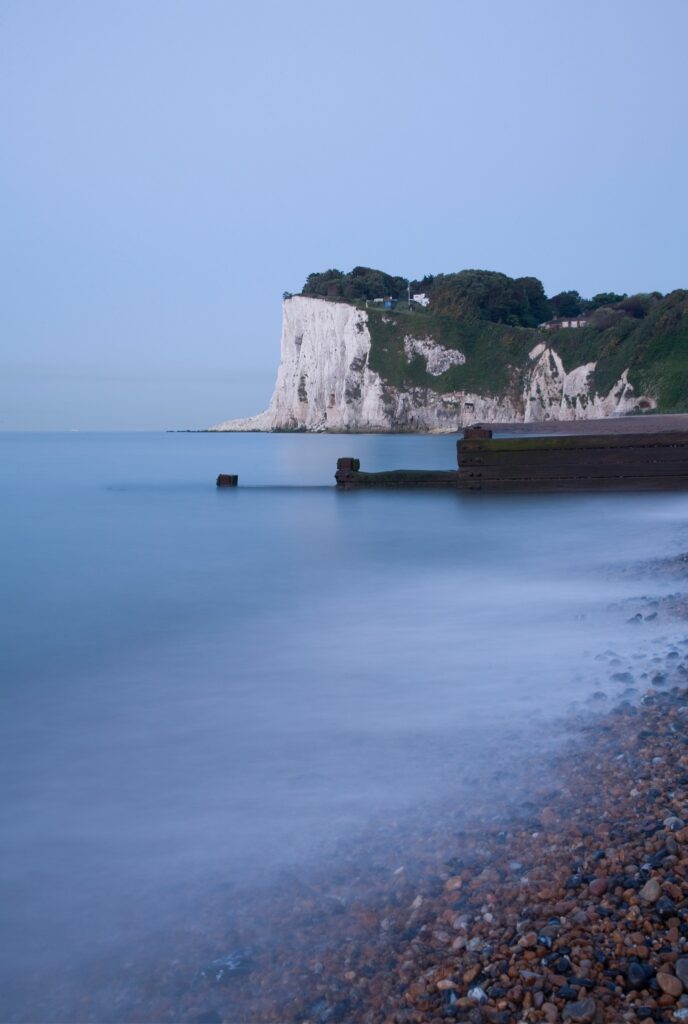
[302,266,662,328]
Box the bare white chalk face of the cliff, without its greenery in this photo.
[212,295,655,432]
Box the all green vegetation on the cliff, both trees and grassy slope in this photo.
[303,266,688,413]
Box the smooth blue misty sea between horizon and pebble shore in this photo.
[0,434,688,1020]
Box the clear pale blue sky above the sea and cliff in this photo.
[0,0,688,430]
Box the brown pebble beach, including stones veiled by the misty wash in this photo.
[30,558,688,1024]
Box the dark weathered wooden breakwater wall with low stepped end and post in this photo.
[335,427,688,492]
